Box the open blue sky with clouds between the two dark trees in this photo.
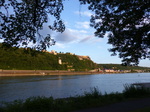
[43,0,150,67]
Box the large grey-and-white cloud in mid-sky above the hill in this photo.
[53,29,101,45]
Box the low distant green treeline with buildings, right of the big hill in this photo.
[98,64,150,70]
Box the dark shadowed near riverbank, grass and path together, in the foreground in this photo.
[0,86,150,112]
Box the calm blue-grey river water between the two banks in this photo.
[0,73,150,102]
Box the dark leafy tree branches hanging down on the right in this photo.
[80,0,150,65]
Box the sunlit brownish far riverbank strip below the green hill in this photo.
[0,70,101,77]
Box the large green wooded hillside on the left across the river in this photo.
[0,44,98,71]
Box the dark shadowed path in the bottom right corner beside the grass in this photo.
[74,98,150,112]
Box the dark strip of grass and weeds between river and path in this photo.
[0,85,150,112]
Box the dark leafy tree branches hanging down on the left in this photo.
[0,0,65,50]
